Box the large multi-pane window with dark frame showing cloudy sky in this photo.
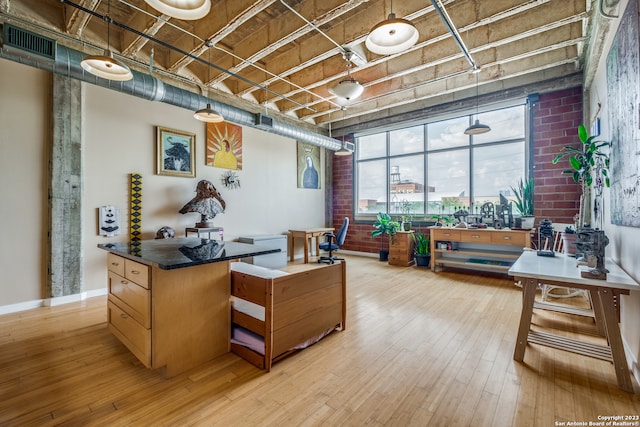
[354,105,527,219]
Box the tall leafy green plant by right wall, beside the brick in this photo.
[552,125,611,231]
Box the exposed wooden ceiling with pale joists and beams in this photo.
[0,0,617,132]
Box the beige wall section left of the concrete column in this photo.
[0,59,51,306]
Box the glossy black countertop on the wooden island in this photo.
[98,237,280,270]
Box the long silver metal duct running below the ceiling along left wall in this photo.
[0,23,355,151]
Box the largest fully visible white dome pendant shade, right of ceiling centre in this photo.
[365,13,419,55]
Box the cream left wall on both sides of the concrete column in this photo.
[0,59,325,307]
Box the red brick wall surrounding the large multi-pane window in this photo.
[332,87,582,253]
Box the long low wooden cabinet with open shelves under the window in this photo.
[429,227,533,272]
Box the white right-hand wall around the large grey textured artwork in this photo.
[585,0,640,378]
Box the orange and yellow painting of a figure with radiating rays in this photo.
[205,122,242,170]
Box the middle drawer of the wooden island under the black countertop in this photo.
[109,271,151,329]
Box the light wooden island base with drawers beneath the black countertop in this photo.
[107,253,231,377]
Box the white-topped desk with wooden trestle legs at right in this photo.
[509,251,640,393]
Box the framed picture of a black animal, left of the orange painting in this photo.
[156,126,196,178]
